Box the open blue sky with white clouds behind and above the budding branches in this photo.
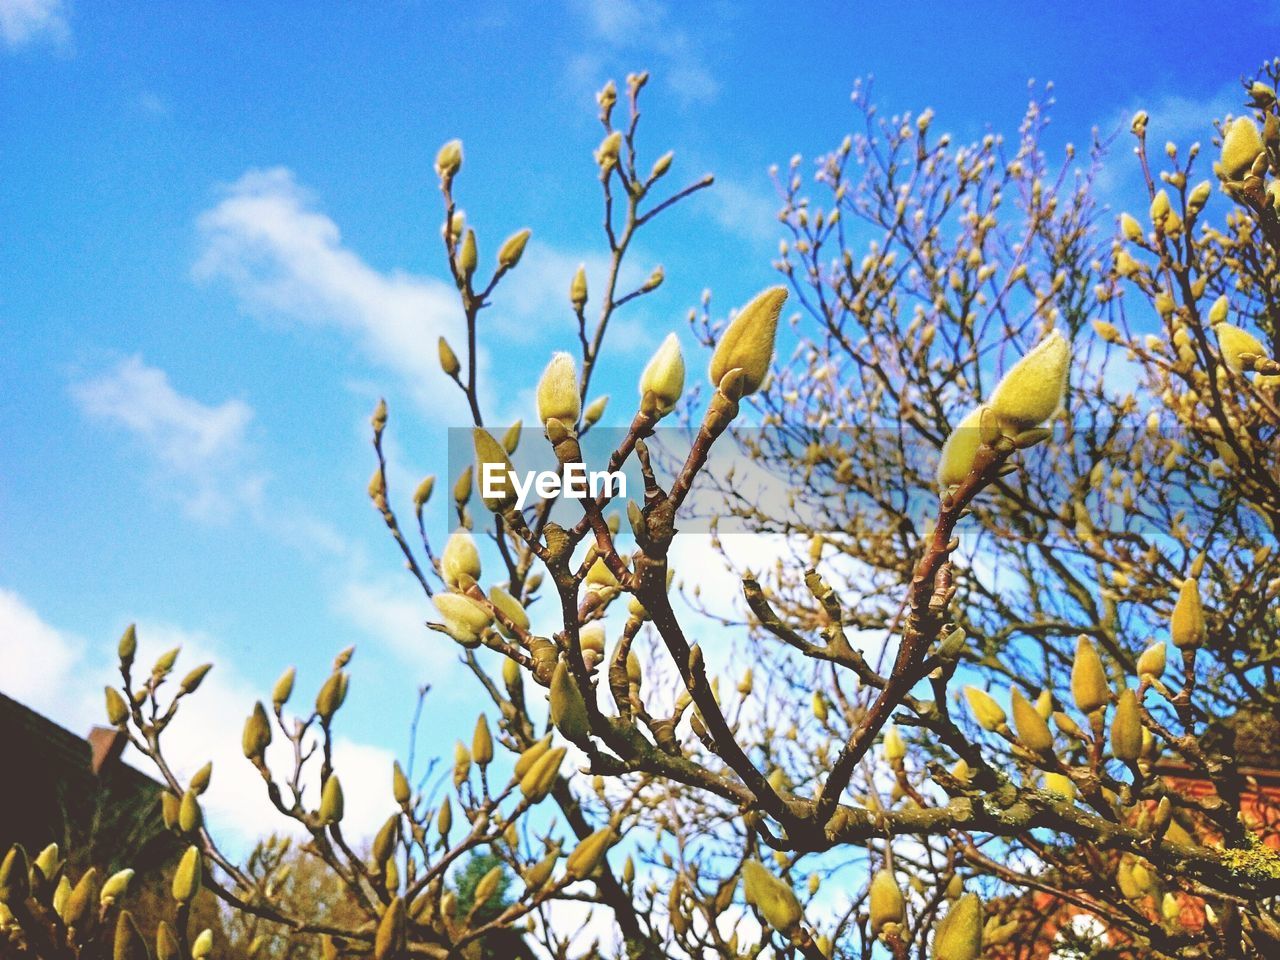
[0,0,1280,839]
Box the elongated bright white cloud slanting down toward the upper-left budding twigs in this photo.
[195,168,486,416]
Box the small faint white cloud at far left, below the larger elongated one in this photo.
[72,356,264,518]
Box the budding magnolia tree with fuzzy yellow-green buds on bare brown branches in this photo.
[0,64,1280,960]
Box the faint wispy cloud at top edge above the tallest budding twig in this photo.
[570,0,719,105]
